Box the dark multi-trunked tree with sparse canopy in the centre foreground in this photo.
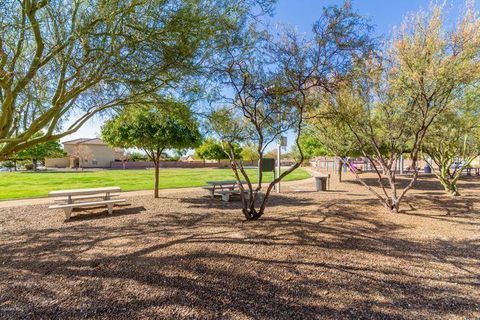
[210,3,372,220]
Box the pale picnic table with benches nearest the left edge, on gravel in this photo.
[48,187,126,220]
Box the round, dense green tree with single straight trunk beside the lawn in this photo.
[102,99,201,198]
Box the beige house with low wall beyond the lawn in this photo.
[45,138,123,168]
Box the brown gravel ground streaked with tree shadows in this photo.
[0,176,480,319]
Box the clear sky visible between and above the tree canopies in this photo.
[62,0,480,147]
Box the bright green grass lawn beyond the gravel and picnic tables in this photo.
[0,168,309,200]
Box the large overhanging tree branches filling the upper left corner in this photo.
[0,0,272,161]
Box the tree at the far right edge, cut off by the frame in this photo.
[423,89,480,197]
